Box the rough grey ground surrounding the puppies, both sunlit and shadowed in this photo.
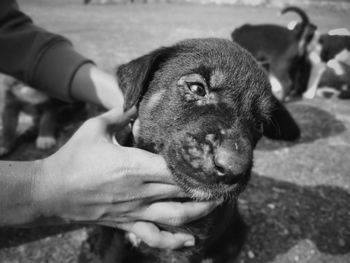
[0,0,350,263]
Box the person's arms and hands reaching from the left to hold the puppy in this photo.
[0,0,217,252]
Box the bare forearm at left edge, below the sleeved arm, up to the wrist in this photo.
[0,161,41,226]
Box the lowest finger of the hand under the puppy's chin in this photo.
[120,222,195,249]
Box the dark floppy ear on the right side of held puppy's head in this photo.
[264,97,300,141]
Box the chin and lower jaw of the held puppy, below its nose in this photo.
[174,173,250,201]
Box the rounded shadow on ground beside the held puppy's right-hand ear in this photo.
[257,103,346,153]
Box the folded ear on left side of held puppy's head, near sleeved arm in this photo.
[116,47,175,110]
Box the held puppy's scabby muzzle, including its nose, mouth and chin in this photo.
[165,134,252,200]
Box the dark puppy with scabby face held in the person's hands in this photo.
[82,39,300,263]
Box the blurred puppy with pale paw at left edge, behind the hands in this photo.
[0,76,84,156]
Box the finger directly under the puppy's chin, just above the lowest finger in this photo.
[133,201,219,226]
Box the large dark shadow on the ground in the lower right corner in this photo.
[240,174,350,263]
